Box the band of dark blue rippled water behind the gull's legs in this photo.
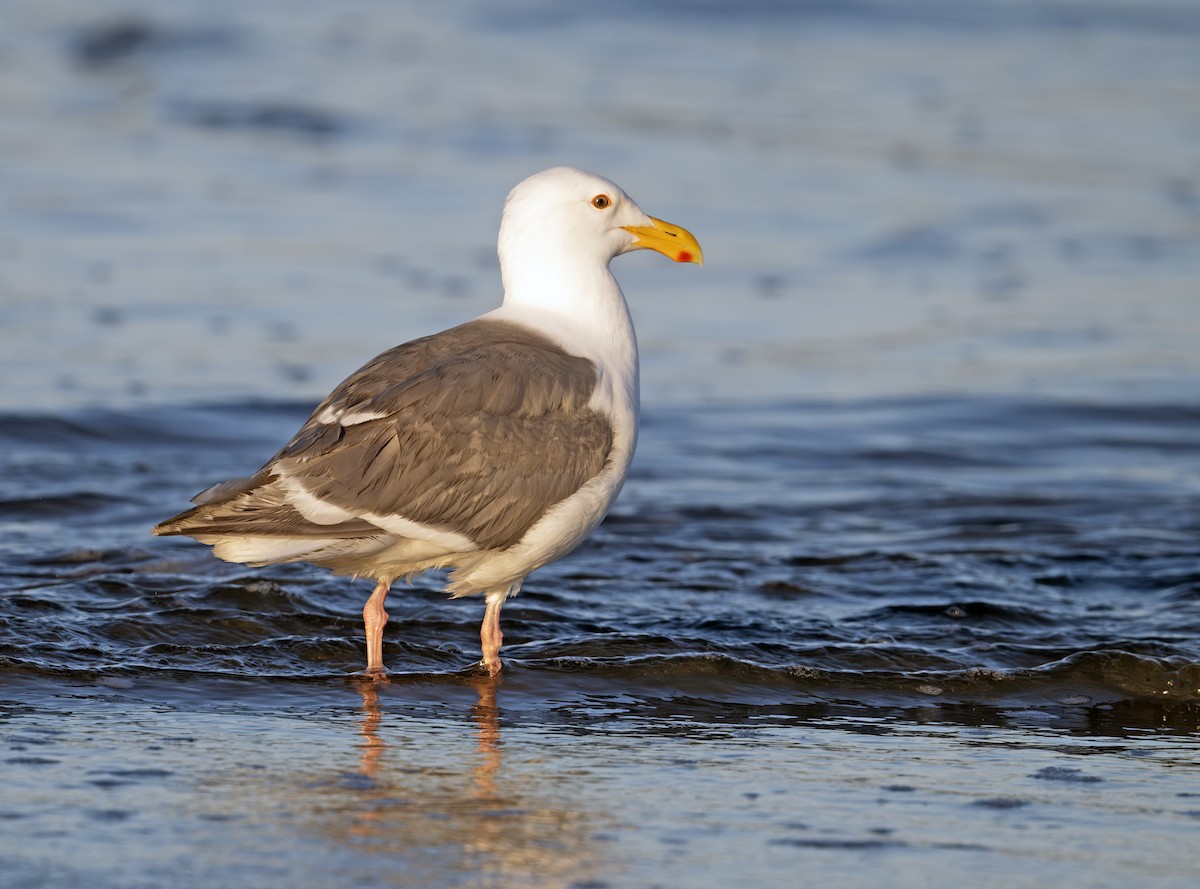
[0,398,1200,710]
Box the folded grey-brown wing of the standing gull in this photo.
[156,322,612,548]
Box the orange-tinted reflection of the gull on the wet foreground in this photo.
[336,675,600,889]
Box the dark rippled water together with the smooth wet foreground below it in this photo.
[7,398,1200,887]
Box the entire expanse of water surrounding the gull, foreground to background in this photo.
[0,0,1200,889]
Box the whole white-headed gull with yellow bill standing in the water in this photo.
[154,167,703,677]
